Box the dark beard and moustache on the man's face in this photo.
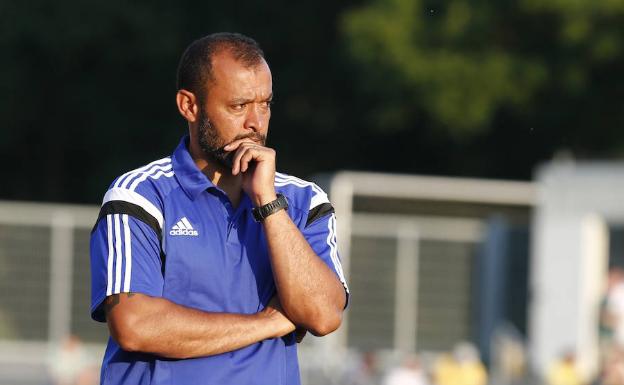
[197,109,266,169]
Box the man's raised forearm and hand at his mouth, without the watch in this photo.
[229,138,346,335]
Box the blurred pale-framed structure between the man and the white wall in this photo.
[314,172,535,356]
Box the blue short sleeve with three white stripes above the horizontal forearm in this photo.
[90,213,164,322]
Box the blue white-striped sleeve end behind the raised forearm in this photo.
[302,209,349,307]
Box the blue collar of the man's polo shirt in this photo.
[171,135,216,200]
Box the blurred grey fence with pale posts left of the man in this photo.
[0,202,108,384]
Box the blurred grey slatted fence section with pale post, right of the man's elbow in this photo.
[346,214,483,352]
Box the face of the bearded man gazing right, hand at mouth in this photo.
[197,52,273,168]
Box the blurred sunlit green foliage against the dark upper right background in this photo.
[342,0,624,137]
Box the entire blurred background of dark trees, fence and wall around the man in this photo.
[0,0,624,385]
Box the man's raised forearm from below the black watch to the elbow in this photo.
[263,210,346,335]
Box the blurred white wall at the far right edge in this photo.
[529,162,624,379]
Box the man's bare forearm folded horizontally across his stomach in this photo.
[107,294,294,358]
